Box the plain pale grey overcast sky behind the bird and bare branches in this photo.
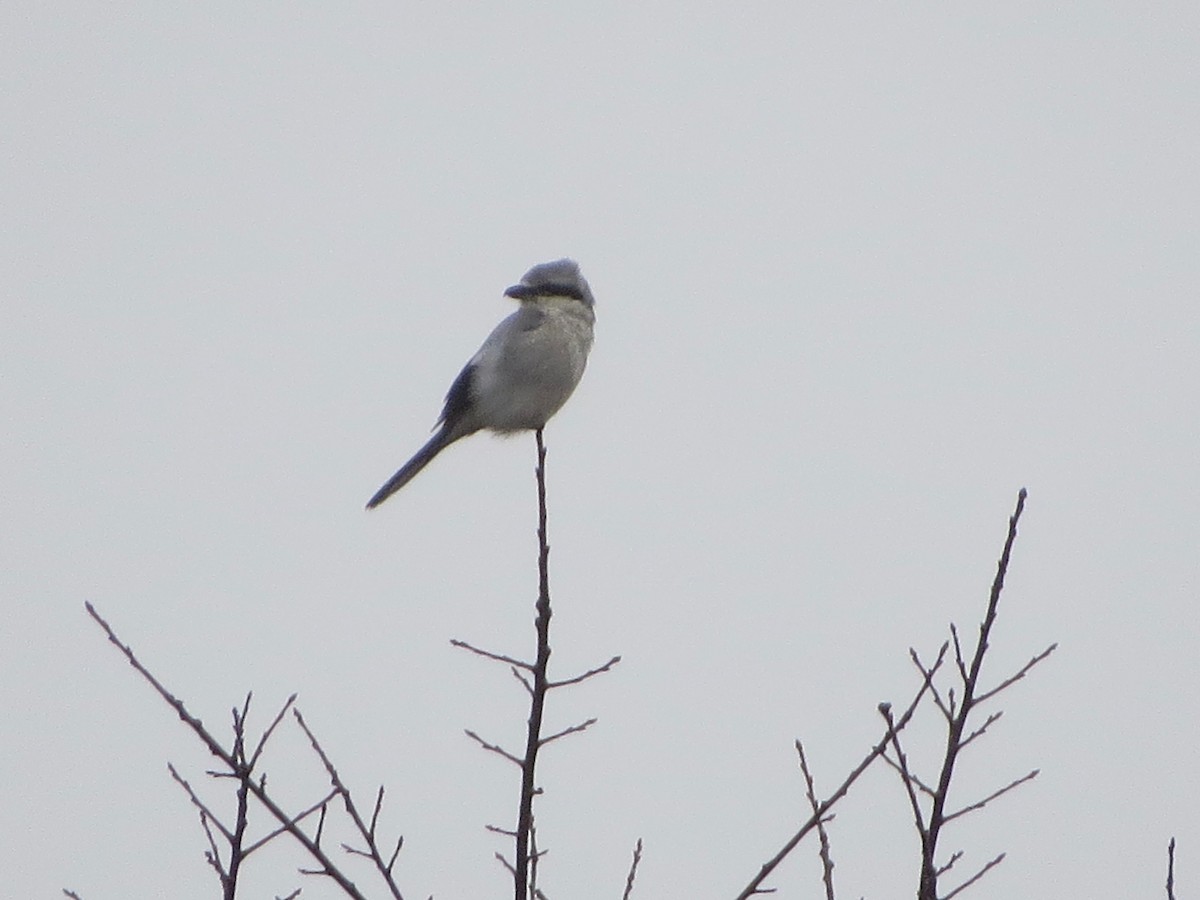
[0,1,1200,900]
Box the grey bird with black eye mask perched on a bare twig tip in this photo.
[366,259,595,509]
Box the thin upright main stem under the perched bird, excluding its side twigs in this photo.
[512,428,551,900]
